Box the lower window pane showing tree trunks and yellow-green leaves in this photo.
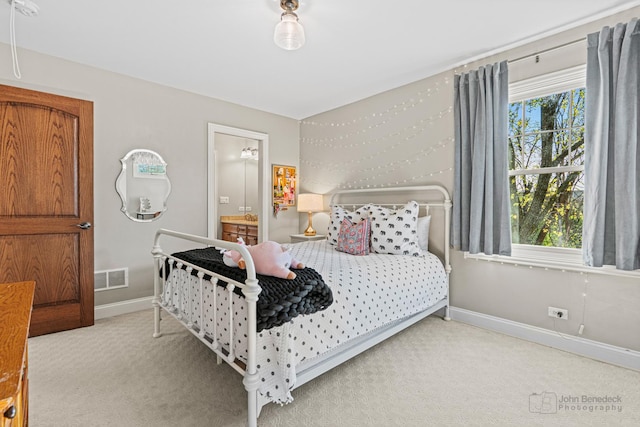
[510,171,584,248]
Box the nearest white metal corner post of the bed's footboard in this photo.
[242,272,262,427]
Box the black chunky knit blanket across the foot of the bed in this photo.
[165,247,333,332]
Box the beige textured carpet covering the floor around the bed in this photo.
[29,310,640,427]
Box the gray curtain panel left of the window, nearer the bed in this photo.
[451,61,511,255]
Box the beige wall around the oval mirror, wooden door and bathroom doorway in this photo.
[0,43,299,305]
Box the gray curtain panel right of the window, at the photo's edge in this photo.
[582,19,640,270]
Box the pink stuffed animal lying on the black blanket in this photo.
[224,241,304,280]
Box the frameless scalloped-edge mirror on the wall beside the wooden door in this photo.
[116,149,171,222]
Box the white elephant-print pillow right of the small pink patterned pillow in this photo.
[369,201,422,256]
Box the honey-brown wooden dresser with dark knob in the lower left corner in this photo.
[0,282,36,427]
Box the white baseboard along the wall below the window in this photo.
[450,307,640,371]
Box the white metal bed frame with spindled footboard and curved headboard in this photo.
[151,185,452,427]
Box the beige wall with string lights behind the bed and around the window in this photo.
[300,7,640,350]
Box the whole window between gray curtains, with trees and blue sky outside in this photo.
[508,67,585,254]
